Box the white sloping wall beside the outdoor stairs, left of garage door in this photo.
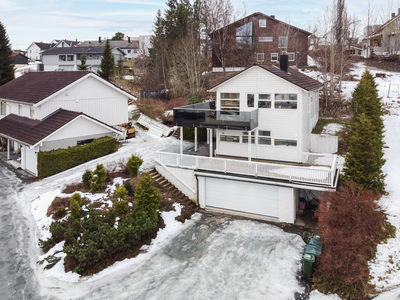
[156,166,197,200]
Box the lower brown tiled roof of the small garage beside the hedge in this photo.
[0,108,114,146]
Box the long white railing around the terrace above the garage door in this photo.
[158,152,336,187]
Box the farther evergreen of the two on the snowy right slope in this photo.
[351,70,384,139]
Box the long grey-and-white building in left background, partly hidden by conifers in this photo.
[42,46,125,71]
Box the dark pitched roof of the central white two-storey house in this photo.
[209,65,323,91]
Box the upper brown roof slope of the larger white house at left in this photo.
[0,71,88,104]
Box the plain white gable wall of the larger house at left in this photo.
[40,77,128,125]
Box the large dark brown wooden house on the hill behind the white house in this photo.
[210,12,311,67]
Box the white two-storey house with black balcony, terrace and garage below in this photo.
[157,56,339,223]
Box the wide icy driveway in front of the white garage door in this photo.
[39,214,304,300]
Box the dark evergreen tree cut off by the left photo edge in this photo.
[0,21,14,85]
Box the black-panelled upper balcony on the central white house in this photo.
[174,101,258,131]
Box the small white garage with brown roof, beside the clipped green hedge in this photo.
[0,109,121,176]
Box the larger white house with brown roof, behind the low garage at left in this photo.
[0,71,136,125]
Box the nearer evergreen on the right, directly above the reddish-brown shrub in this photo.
[344,113,385,193]
